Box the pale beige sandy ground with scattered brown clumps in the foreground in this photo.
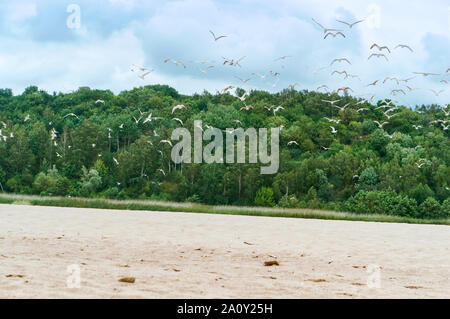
[0,205,450,298]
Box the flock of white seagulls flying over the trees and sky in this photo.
[0,19,450,184]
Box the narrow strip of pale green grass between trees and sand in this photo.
[0,194,450,225]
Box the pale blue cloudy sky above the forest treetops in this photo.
[0,0,450,106]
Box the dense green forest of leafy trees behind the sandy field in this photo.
[0,85,450,218]
